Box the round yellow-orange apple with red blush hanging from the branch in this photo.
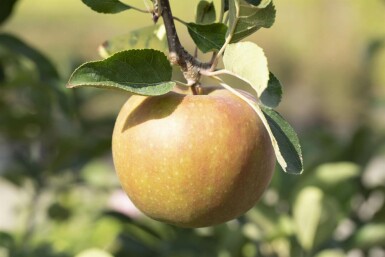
[112,89,275,228]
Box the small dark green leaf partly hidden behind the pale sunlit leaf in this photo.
[260,72,282,108]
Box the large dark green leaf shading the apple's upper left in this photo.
[67,49,175,95]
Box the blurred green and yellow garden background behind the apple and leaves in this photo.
[0,0,385,257]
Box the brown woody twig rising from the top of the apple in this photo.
[159,0,212,88]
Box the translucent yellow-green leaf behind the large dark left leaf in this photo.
[99,24,167,58]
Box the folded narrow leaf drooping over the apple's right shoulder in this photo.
[216,83,303,174]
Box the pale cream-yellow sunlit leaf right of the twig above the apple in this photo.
[223,42,269,97]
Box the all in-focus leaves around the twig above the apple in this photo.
[68,0,303,174]
